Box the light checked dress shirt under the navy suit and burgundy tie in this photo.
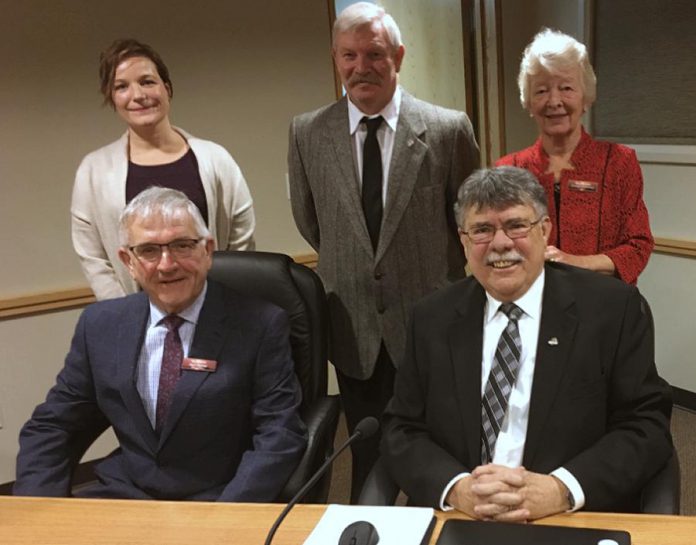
[136,282,208,429]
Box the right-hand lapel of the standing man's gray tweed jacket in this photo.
[378,91,428,261]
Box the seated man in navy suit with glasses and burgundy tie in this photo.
[14,187,306,502]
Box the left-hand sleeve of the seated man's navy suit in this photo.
[13,313,109,496]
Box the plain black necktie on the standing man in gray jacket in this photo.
[360,116,382,251]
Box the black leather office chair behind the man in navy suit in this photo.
[209,252,339,503]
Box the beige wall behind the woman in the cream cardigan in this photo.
[0,0,334,482]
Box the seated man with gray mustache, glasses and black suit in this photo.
[382,167,672,522]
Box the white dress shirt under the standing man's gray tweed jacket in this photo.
[347,85,401,206]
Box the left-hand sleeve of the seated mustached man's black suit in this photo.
[381,306,473,509]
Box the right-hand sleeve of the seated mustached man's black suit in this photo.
[563,289,672,511]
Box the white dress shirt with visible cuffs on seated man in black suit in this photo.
[440,269,585,511]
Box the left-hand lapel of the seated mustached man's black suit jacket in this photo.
[447,281,486,468]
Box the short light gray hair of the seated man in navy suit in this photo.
[118,186,210,246]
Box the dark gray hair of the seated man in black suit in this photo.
[454,166,549,229]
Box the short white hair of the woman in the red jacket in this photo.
[517,28,597,109]
